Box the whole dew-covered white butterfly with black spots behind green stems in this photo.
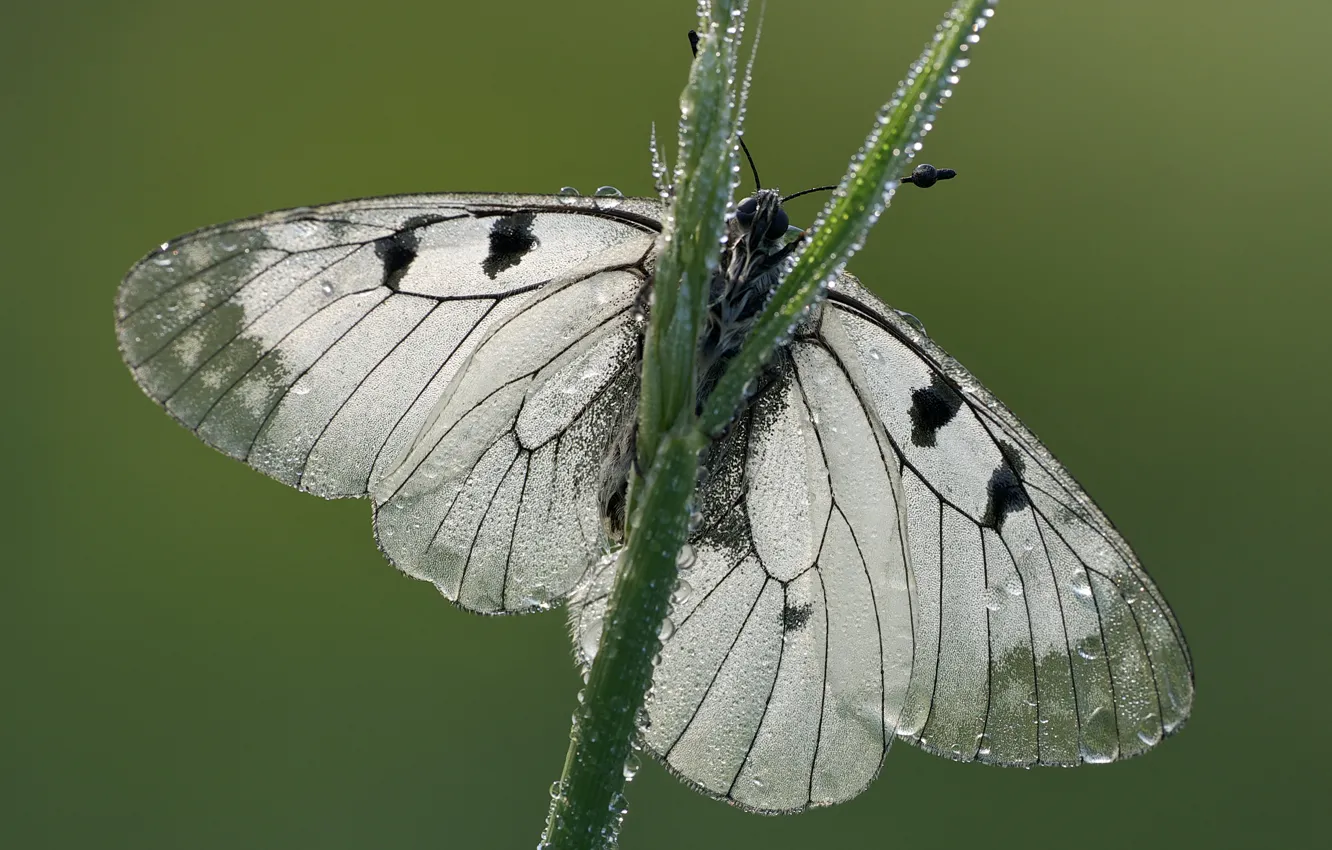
[116,191,1193,811]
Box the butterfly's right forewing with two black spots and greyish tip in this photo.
[819,277,1193,765]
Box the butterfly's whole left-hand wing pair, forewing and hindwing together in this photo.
[117,195,661,612]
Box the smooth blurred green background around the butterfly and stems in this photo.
[0,0,1332,850]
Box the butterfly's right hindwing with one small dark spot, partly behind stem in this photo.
[571,340,912,811]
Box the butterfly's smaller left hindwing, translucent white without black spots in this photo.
[372,265,643,613]
